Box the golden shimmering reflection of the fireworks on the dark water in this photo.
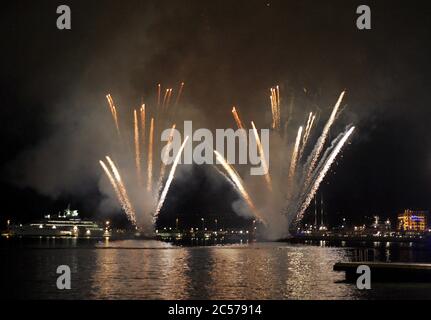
[91,243,356,299]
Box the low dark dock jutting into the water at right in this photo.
[334,262,431,282]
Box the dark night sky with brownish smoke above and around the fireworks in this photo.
[0,0,431,229]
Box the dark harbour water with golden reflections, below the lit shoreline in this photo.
[0,239,431,300]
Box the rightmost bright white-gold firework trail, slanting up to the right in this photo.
[296,127,355,220]
